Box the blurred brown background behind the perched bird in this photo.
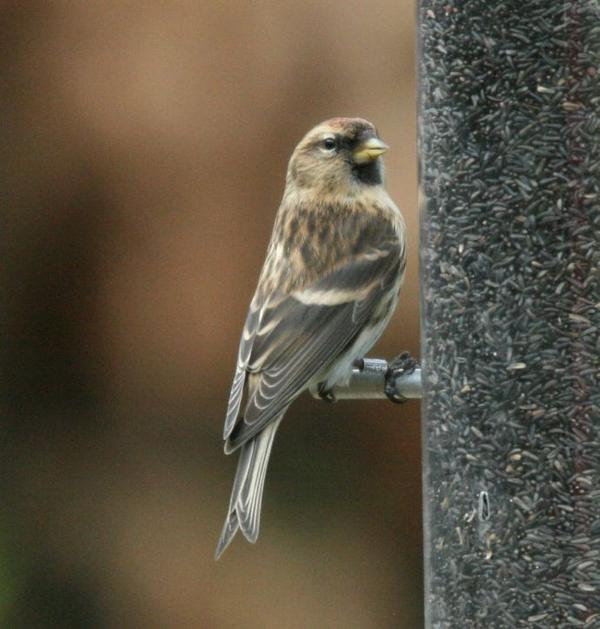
[0,0,422,629]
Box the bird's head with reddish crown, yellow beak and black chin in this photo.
[287,118,388,196]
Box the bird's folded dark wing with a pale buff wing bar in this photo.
[225,237,404,452]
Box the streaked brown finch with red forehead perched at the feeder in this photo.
[215,117,406,559]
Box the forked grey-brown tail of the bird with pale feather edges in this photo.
[215,417,282,559]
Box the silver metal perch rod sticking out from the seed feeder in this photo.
[310,358,422,400]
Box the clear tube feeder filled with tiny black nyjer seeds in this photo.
[419,0,600,629]
